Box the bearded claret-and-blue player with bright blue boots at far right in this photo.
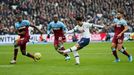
[110,9,133,62]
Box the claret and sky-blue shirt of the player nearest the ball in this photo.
[15,20,30,36]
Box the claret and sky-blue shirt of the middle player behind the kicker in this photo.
[49,21,66,37]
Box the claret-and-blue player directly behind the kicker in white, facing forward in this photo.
[47,14,70,60]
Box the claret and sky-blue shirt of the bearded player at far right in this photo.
[114,19,127,35]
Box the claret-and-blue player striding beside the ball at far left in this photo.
[10,15,43,64]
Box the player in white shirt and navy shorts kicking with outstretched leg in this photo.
[59,17,104,65]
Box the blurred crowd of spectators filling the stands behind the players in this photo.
[0,0,134,35]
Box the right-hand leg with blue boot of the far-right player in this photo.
[117,39,133,62]
